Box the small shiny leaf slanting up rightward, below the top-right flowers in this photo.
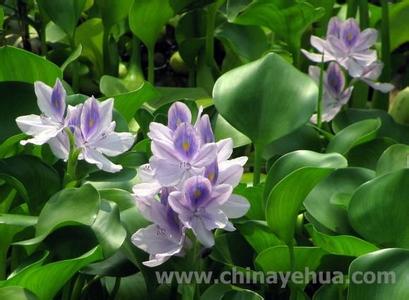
[327,119,382,154]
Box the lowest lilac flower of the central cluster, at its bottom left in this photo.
[132,188,189,267]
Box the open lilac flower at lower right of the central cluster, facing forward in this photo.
[169,176,234,247]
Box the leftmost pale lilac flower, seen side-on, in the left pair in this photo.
[16,79,66,145]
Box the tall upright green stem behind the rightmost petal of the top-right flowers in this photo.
[373,0,391,110]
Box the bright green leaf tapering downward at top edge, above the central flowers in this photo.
[129,0,173,49]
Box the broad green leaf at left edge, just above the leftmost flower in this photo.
[0,46,62,85]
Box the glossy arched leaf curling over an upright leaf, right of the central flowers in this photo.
[264,150,345,200]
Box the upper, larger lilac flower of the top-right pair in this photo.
[302,17,378,77]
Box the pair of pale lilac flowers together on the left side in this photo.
[16,79,135,172]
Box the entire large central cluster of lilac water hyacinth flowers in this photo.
[132,102,250,266]
